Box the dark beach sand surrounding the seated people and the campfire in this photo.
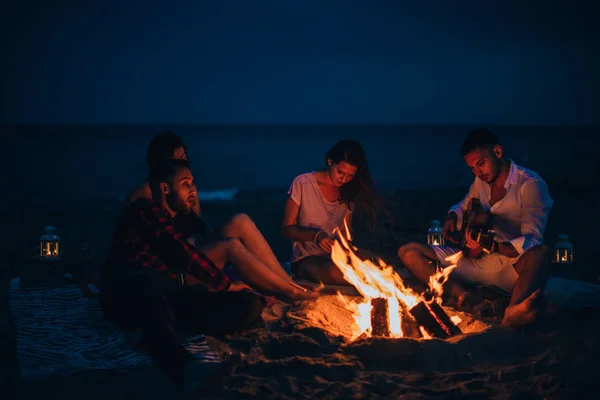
[0,187,600,399]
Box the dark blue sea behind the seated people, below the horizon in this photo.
[2,125,600,204]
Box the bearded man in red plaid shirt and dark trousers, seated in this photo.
[100,160,263,390]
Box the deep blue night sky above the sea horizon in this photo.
[0,0,600,125]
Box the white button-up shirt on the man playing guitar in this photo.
[449,160,554,255]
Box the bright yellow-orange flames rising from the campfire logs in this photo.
[331,220,462,340]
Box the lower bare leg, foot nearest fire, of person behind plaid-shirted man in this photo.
[200,239,316,300]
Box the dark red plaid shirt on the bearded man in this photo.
[106,198,230,290]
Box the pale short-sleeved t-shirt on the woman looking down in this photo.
[288,171,352,262]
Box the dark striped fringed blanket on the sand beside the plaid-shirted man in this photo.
[8,286,219,379]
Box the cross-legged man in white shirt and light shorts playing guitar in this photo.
[398,129,553,327]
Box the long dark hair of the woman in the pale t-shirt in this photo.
[325,140,380,225]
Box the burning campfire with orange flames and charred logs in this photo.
[331,222,462,341]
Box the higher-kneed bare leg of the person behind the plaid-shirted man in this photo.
[221,214,289,279]
